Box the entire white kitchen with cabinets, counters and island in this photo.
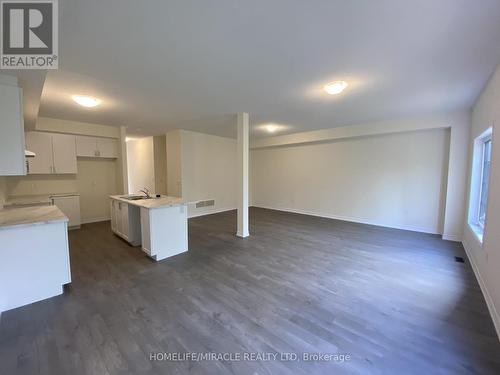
[0,75,188,314]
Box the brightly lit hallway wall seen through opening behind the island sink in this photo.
[127,137,155,194]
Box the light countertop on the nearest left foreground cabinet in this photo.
[0,206,68,229]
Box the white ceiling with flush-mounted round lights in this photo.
[40,0,500,137]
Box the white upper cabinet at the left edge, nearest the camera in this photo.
[0,77,26,176]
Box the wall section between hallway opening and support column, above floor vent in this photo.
[179,130,237,217]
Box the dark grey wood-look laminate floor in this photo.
[0,209,500,375]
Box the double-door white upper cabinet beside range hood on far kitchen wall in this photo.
[26,132,77,174]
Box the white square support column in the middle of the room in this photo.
[236,112,250,237]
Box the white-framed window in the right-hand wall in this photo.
[469,128,492,242]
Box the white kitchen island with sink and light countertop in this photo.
[110,195,191,261]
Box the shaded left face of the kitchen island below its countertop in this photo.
[111,200,141,246]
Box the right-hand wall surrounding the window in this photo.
[463,65,500,336]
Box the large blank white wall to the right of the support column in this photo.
[252,129,449,233]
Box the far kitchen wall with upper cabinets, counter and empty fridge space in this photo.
[4,129,118,229]
